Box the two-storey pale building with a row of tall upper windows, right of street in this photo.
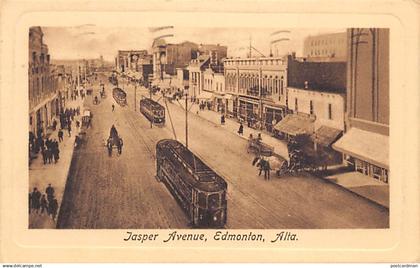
[223,57,287,130]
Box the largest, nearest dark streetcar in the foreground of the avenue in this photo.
[156,139,227,228]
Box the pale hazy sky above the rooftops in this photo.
[42,24,345,61]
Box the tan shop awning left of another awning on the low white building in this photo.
[274,114,315,136]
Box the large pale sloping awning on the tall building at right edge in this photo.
[332,128,389,169]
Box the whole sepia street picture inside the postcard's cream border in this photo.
[28,24,392,229]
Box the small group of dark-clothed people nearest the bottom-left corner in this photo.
[29,184,58,221]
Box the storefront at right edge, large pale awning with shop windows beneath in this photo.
[332,128,389,183]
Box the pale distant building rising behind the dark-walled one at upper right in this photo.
[303,32,347,61]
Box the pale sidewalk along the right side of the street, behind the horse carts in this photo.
[166,96,389,208]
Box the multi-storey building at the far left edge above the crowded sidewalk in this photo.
[28,27,60,136]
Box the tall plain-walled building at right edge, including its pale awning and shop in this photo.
[333,28,389,183]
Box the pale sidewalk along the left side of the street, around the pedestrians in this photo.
[29,98,83,229]
